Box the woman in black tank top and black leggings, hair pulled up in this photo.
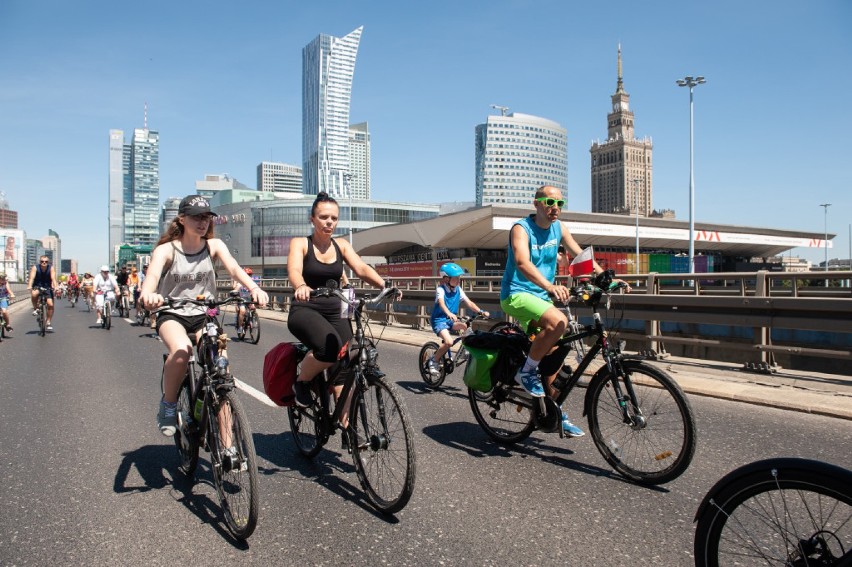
[287,192,392,425]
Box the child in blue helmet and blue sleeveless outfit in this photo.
[426,262,489,376]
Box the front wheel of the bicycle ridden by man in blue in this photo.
[586,360,696,484]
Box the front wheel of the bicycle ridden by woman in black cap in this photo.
[207,391,259,539]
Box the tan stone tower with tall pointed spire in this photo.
[589,44,653,216]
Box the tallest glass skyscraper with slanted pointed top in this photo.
[302,26,364,197]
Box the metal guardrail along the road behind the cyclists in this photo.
[223,271,852,372]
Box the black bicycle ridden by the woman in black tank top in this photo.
[287,280,417,514]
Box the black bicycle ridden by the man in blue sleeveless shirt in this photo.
[468,270,696,485]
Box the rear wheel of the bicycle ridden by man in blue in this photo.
[467,384,535,445]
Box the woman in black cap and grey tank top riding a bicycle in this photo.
[139,195,269,436]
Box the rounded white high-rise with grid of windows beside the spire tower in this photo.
[475,112,568,206]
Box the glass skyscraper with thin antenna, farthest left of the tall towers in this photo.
[109,128,160,258]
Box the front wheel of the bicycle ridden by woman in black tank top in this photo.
[345,375,417,514]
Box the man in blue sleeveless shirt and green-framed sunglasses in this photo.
[500,185,603,437]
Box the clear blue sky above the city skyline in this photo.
[0,0,852,269]
